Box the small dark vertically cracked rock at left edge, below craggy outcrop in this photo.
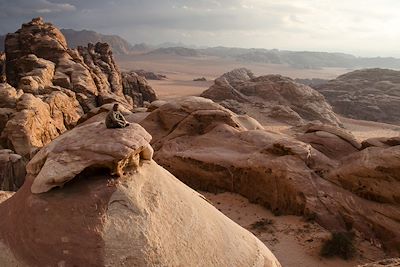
[0,149,26,192]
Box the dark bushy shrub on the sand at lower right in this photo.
[320,232,356,260]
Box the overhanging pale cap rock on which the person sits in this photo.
[26,122,153,193]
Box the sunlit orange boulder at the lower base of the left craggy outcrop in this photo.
[3,92,83,158]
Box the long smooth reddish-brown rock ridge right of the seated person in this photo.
[140,97,400,253]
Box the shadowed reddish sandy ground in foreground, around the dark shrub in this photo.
[200,192,387,267]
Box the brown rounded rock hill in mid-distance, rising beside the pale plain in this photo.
[201,69,340,125]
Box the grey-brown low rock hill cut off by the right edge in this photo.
[314,69,400,125]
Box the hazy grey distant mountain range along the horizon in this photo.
[0,29,400,69]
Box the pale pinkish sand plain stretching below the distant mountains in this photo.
[116,55,349,99]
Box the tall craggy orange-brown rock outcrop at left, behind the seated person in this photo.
[0,18,157,172]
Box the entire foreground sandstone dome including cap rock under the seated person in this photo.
[0,120,280,267]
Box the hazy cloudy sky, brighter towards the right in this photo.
[0,0,400,57]
